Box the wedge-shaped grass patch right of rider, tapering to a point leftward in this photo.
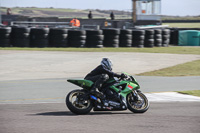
[138,60,200,77]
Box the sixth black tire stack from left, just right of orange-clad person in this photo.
[85,30,104,48]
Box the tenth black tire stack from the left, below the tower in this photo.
[144,29,154,48]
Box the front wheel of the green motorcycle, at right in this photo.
[127,92,149,113]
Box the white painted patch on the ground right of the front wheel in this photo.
[145,92,200,102]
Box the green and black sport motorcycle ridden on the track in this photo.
[66,74,149,114]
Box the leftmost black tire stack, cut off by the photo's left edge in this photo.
[0,27,11,47]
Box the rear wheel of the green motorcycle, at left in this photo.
[66,90,93,115]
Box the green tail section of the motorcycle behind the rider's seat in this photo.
[67,79,94,88]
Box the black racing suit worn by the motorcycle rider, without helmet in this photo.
[84,65,121,90]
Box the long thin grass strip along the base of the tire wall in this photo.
[0,46,200,55]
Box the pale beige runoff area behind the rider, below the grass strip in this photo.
[0,50,200,81]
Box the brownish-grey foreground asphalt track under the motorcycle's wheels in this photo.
[0,102,200,133]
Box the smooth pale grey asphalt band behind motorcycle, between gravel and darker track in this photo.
[0,76,200,104]
